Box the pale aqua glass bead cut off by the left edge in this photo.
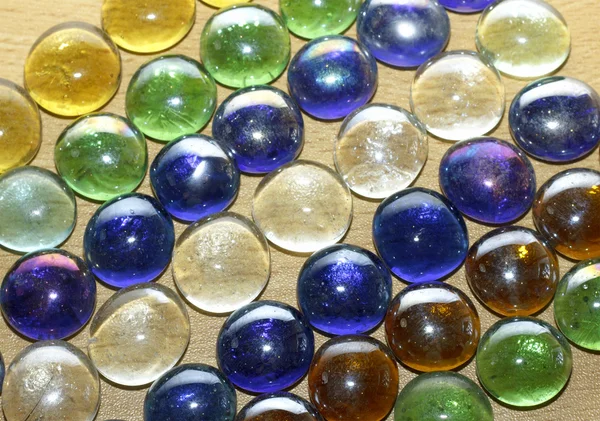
[0,166,77,253]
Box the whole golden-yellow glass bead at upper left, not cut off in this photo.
[25,22,121,117]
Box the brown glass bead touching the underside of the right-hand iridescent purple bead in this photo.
[465,226,560,316]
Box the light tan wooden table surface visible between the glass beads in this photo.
[0,0,600,421]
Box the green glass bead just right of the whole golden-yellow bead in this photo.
[125,55,217,141]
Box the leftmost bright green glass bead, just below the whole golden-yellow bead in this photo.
[54,113,148,201]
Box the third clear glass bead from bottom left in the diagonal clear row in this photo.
[173,212,271,314]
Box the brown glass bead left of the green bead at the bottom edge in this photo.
[308,335,398,421]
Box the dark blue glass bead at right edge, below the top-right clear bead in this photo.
[508,76,600,162]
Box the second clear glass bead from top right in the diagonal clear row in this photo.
[410,51,505,141]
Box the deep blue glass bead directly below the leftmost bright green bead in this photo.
[83,193,175,288]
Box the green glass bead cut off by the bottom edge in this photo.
[394,371,494,421]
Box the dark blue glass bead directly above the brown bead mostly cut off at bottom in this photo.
[217,301,315,393]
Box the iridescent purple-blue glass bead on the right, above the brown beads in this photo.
[439,137,535,224]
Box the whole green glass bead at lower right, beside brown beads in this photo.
[476,317,573,407]
